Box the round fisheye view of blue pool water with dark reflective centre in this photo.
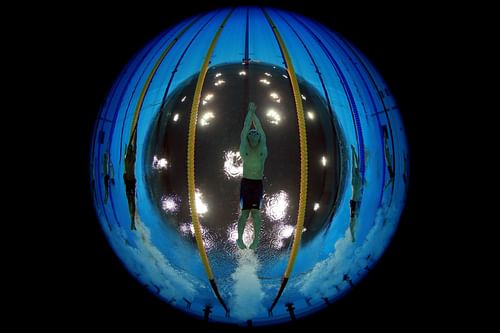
[90,7,409,325]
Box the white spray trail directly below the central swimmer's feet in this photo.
[230,250,266,320]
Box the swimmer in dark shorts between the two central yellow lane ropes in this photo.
[236,102,267,250]
